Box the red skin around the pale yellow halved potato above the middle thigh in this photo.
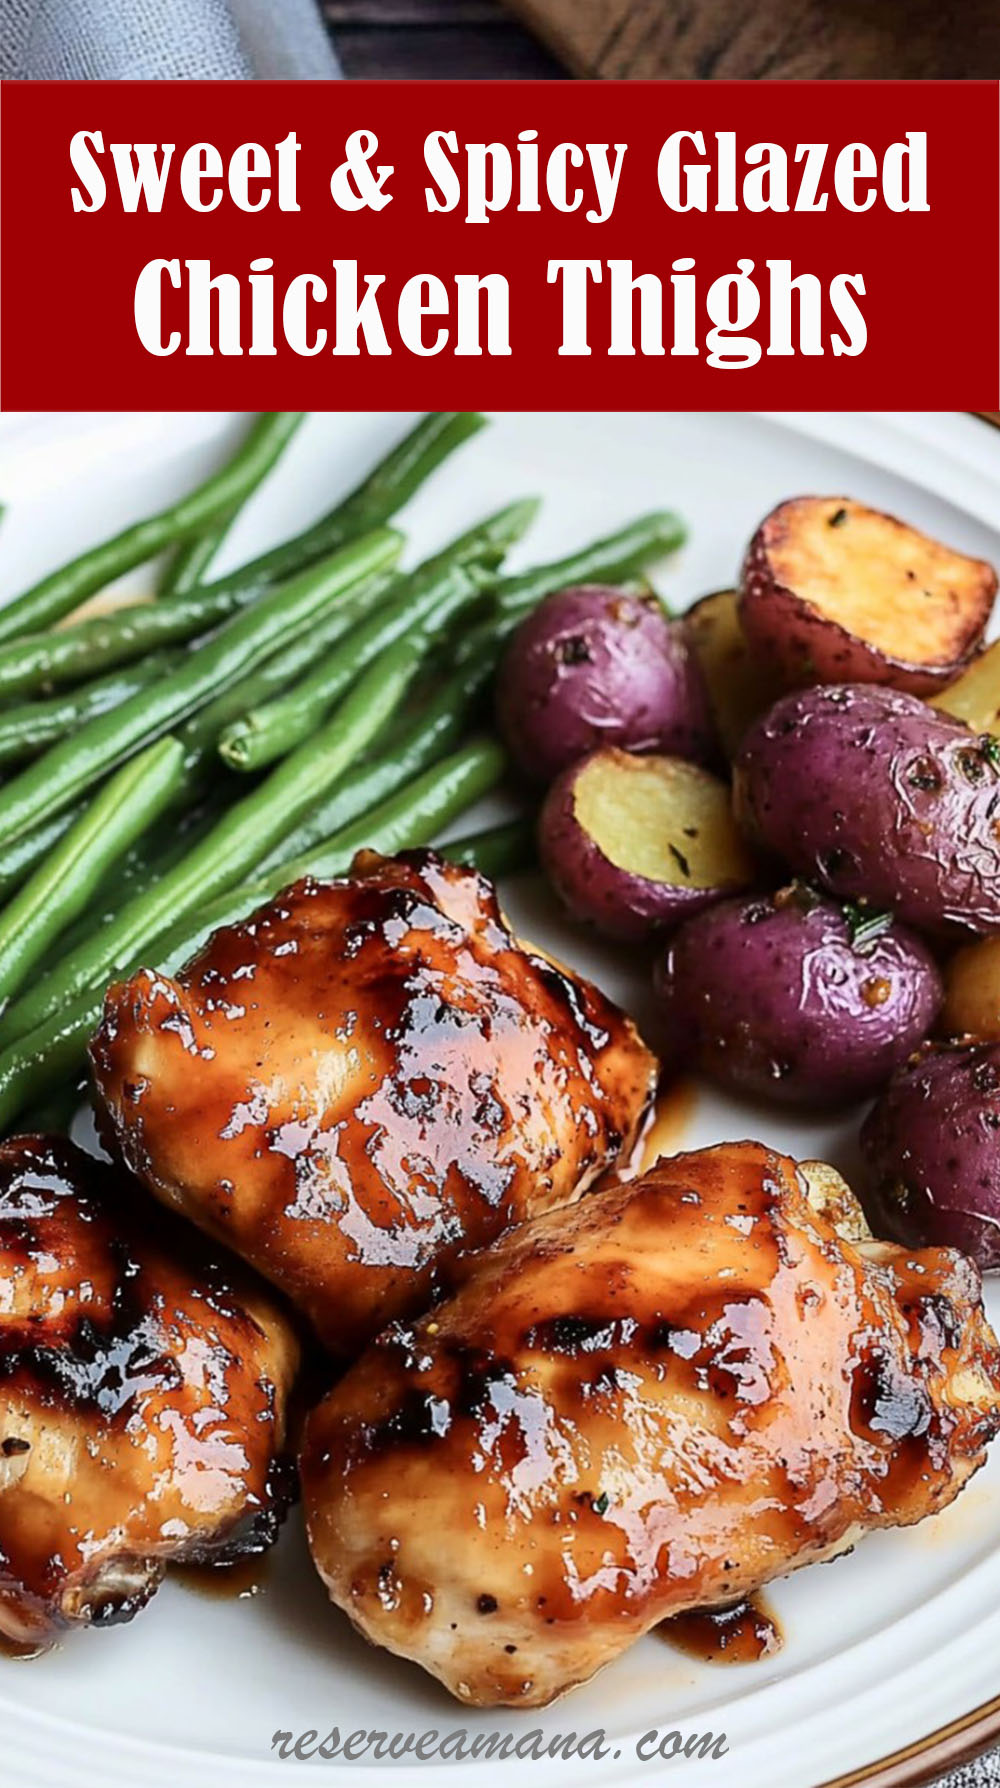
[538,747,753,942]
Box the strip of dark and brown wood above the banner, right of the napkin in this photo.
[320,0,1000,80]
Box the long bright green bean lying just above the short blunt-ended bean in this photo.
[0,527,403,846]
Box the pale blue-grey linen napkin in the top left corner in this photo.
[0,0,340,80]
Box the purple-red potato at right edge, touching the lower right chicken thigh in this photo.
[860,1042,1000,1268]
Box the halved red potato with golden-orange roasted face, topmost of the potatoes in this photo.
[739,497,996,696]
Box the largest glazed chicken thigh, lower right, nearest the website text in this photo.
[301,1143,1000,1706]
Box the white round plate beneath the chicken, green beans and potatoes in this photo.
[0,415,1000,1788]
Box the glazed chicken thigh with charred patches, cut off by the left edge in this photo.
[0,1135,297,1645]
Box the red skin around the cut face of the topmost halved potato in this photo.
[739,497,996,696]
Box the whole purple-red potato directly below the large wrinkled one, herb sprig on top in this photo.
[657,887,941,1107]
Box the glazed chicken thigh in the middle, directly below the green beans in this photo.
[91,853,655,1354]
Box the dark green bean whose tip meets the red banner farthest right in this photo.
[169,409,487,615]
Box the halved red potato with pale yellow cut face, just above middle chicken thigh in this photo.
[538,747,753,939]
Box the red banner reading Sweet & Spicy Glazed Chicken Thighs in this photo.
[0,82,1000,409]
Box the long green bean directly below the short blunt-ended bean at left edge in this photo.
[0,640,420,1041]
